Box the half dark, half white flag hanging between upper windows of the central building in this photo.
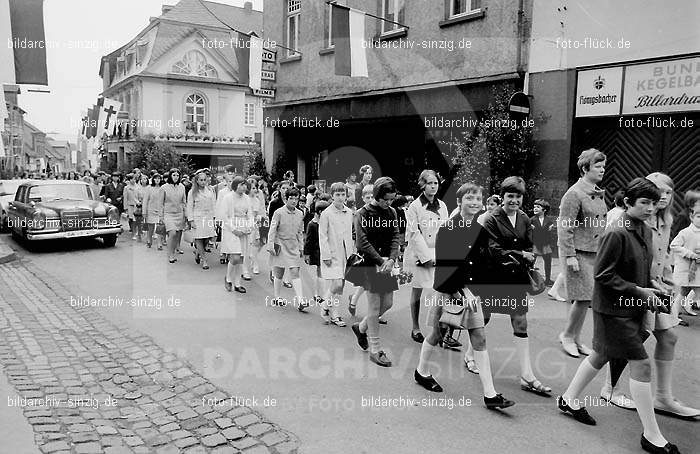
[331,3,368,77]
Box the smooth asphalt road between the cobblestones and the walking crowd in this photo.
[3,231,700,454]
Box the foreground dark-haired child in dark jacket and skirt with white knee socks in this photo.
[557,178,679,453]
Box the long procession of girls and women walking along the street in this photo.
[96,149,700,453]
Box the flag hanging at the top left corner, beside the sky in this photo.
[0,0,48,85]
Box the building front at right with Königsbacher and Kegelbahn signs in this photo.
[528,0,700,211]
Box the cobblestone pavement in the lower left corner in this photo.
[0,261,298,454]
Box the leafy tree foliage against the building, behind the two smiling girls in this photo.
[453,85,543,211]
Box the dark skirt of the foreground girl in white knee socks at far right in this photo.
[593,311,649,360]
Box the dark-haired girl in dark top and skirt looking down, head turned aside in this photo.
[352,177,401,367]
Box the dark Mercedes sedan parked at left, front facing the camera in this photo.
[8,180,122,247]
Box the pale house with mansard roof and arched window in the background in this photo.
[100,0,262,174]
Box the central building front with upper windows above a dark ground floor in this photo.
[264,0,531,199]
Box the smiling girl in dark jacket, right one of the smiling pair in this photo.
[483,177,552,396]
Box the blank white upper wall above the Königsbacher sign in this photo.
[529,0,700,72]
